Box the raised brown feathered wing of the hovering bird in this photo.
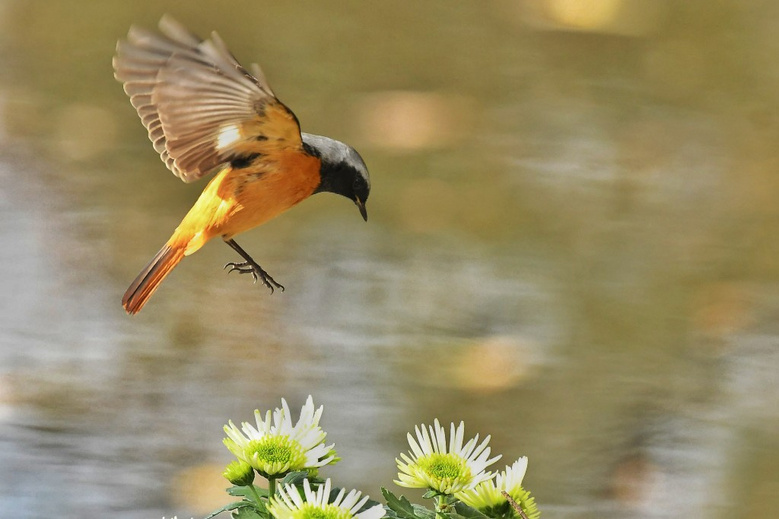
[113,16,302,182]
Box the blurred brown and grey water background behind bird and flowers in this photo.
[0,0,779,519]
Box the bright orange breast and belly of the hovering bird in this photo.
[170,150,321,255]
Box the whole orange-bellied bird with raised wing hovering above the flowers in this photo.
[113,15,371,315]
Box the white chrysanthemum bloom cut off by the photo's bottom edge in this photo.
[268,479,384,519]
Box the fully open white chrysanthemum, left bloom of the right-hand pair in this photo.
[395,419,500,495]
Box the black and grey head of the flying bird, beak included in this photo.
[302,133,371,221]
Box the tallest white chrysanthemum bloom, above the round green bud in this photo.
[223,395,335,476]
